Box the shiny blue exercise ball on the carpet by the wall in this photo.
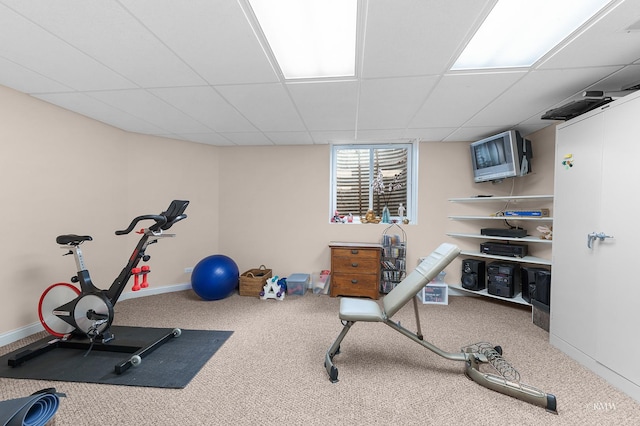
[191,254,240,300]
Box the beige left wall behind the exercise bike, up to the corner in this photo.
[0,86,219,334]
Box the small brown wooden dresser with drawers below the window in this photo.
[329,242,382,299]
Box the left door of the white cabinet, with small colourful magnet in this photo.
[549,113,603,357]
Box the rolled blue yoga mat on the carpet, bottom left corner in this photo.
[0,388,64,426]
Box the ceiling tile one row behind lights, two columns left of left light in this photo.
[149,86,257,132]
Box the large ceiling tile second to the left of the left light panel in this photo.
[5,0,205,87]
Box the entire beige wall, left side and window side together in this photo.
[0,82,555,335]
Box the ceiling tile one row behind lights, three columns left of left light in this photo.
[87,89,213,133]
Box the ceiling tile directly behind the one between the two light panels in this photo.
[358,77,438,130]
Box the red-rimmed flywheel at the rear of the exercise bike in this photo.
[38,283,80,337]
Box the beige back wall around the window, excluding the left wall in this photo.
[219,128,555,282]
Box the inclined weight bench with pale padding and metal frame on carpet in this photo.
[324,243,557,414]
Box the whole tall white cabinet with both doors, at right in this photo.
[550,93,640,392]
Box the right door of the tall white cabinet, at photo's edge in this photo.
[593,98,640,386]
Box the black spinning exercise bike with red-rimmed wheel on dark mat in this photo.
[8,200,189,374]
